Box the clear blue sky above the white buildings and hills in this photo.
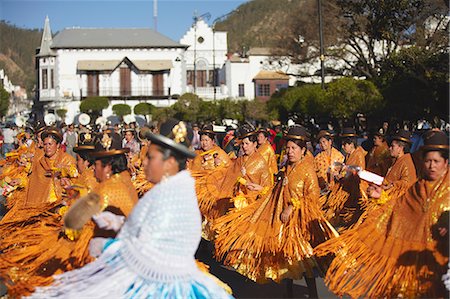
[0,0,249,41]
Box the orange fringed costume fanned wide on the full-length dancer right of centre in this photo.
[214,155,333,282]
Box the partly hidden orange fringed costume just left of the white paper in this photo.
[325,146,367,227]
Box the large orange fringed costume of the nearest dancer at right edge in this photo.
[315,170,450,298]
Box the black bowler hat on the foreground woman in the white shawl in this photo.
[146,118,196,158]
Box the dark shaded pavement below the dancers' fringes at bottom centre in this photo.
[197,241,338,299]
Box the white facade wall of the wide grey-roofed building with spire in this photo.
[39,48,186,120]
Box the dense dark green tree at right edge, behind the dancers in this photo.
[377,47,450,119]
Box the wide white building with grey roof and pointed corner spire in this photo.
[35,18,187,123]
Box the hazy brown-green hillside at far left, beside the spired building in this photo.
[0,20,42,93]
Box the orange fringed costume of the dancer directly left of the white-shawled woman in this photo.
[0,174,137,296]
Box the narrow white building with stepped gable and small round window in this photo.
[180,19,229,99]
